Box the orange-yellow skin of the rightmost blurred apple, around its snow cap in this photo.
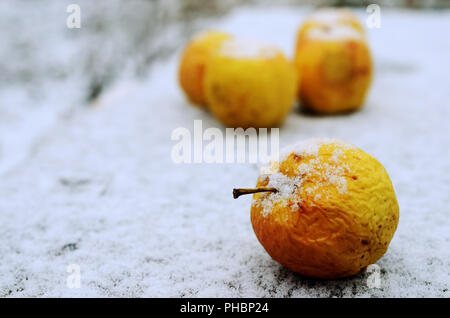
[295,9,373,114]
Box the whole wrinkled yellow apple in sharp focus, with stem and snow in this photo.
[233,139,399,278]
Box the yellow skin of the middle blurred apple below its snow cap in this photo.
[205,52,297,129]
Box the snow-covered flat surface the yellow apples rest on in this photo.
[0,7,450,297]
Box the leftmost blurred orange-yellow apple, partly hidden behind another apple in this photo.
[178,31,231,107]
